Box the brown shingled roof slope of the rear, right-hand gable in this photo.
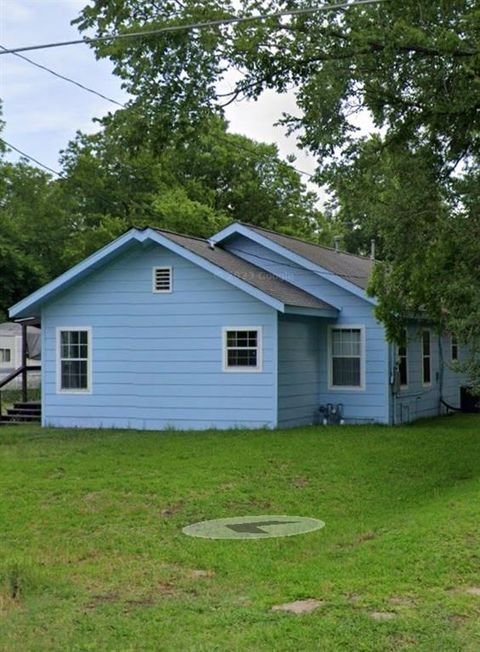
[243,224,374,290]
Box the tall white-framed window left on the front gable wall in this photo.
[57,328,91,393]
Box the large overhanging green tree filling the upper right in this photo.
[77,0,480,380]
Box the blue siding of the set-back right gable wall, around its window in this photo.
[224,236,390,423]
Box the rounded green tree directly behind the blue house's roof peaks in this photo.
[59,112,325,262]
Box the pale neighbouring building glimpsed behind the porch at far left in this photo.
[0,322,40,389]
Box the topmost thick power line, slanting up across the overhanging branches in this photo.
[0,0,387,55]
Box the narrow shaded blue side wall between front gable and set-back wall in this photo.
[278,315,320,427]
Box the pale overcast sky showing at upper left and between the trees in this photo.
[0,0,326,185]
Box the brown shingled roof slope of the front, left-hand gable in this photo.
[157,229,334,310]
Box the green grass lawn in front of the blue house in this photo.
[0,416,480,652]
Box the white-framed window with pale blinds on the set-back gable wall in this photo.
[330,327,364,389]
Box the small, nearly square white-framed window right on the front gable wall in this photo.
[223,327,262,371]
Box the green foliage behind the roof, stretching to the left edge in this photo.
[0,107,325,319]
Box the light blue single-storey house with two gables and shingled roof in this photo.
[6,223,463,429]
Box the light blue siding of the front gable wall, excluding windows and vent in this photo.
[42,246,277,429]
